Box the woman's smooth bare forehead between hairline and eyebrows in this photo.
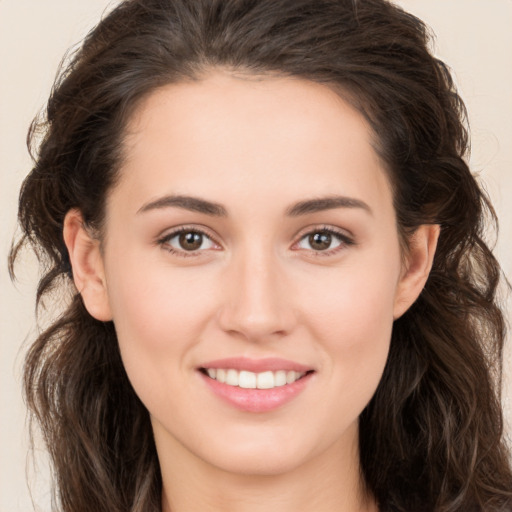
[113,72,389,216]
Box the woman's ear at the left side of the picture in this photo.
[63,209,112,322]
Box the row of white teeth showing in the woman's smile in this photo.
[206,368,304,389]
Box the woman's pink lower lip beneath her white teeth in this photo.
[201,373,313,412]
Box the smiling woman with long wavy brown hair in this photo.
[11,0,512,512]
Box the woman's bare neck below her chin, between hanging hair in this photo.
[159,424,377,512]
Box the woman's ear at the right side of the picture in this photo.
[393,224,440,320]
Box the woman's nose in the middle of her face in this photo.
[218,249,296,342]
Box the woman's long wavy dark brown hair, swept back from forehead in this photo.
[10,0,512,512]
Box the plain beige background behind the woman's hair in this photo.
[0,0,512,512]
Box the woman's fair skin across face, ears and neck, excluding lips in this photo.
[64,71,438,512]
